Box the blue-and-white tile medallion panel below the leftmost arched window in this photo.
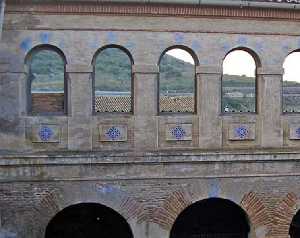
[31,124,61,143]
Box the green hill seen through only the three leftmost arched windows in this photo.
[31,49,194,92]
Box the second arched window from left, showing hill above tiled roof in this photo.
[93,45,133,113]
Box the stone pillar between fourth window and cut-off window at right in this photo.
[257,66,283,148]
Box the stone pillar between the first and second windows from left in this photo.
[66,65,93,151]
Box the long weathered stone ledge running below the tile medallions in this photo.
[0,149,300,167]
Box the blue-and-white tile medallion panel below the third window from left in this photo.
[166,123,192,141]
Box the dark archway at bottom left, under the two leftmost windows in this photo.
[45,203,133,238]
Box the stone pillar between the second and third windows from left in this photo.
[133,65,159,150]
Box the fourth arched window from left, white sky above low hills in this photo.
[222,49,257,113]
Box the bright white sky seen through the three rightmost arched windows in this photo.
[167,49,300,82]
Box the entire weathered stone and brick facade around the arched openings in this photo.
[0,1,300,238]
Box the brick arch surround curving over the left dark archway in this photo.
[33,184,143,237]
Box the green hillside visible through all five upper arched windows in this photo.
[31,49,300,111]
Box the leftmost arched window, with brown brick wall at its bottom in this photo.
[26,45,67,115]
